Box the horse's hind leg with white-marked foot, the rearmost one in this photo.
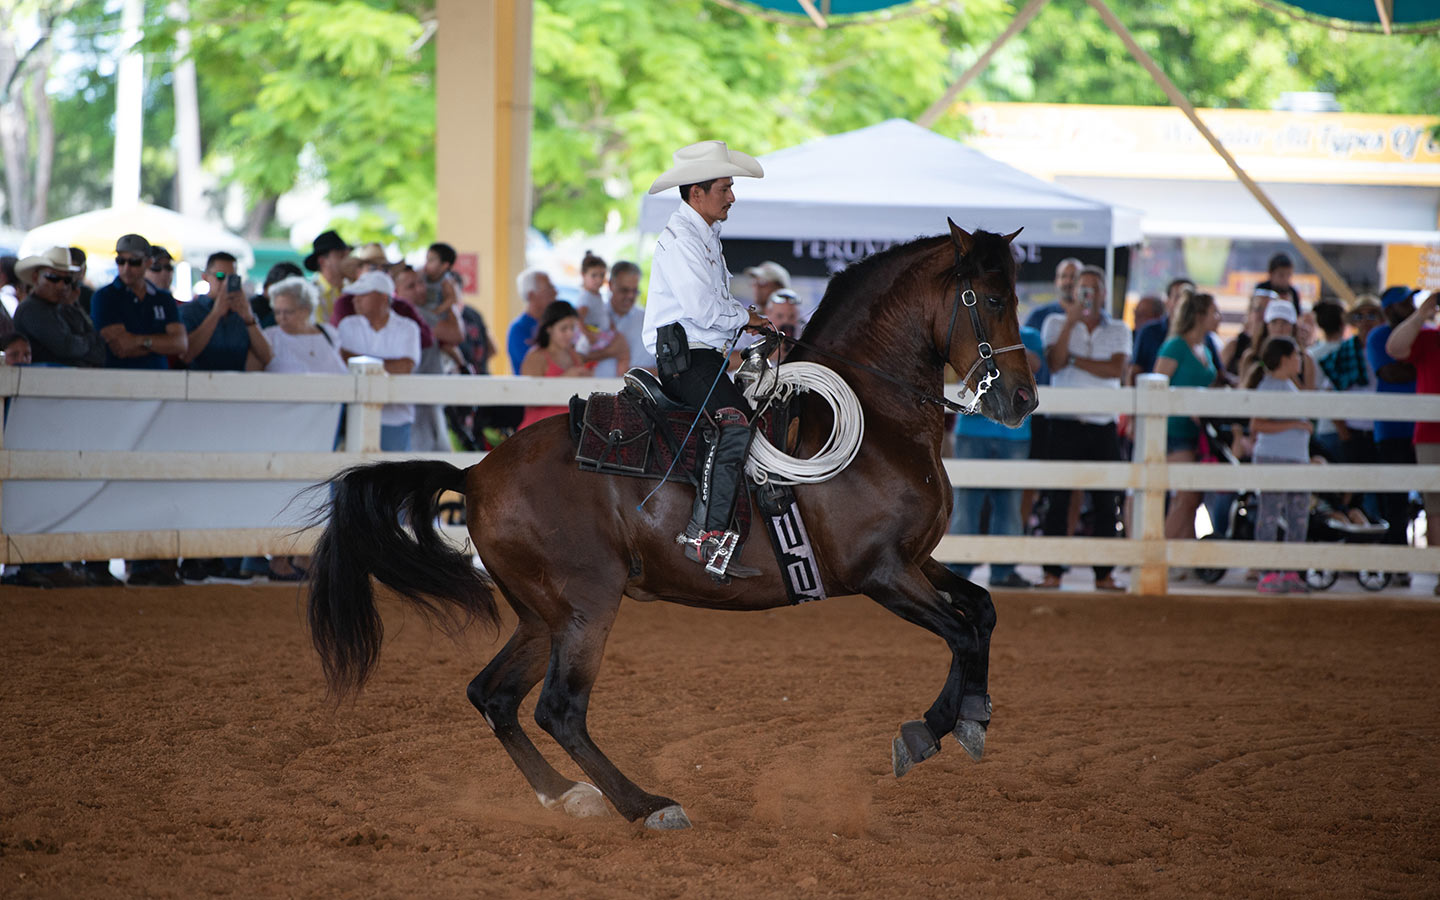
[465,606,606,816]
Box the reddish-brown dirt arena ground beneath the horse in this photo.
[0,586,1440,899]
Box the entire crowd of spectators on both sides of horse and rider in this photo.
[0,230,1422,592]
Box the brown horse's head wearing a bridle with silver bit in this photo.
[933,222,1038,428]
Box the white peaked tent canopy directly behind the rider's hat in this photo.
[639,120,1140,246]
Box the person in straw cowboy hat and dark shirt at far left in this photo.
[14,246,105,367]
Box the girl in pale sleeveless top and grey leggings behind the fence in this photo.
[1246,337,1315,593]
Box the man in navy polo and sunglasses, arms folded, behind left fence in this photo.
[91,235,187,369]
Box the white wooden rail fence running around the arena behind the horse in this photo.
[0,363,1440,593]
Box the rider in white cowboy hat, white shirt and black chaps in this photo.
[644,141,769,577]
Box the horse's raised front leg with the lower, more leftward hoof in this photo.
[865,566,981,778]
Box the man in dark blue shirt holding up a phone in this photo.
[180,251,271,372]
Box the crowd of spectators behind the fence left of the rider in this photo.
[0,230,685,588]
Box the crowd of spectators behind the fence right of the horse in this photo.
[950,253,1440,593]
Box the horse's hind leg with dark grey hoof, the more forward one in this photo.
[536,589,690,829]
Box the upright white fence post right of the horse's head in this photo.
[1130,374,1169,593]
